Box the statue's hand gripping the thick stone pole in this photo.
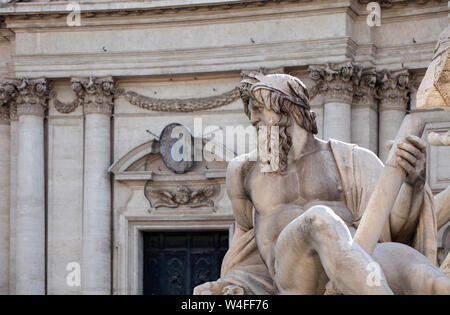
[395,136,426,190]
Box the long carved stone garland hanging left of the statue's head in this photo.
[125,87,240,112]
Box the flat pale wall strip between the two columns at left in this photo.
[47,116,84,295]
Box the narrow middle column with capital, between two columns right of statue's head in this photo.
[352,68,378,153]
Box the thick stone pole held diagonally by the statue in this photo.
[353,114,425,255]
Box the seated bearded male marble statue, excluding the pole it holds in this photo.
[194,73,450,294]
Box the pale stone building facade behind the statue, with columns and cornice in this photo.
[0,0,450,294]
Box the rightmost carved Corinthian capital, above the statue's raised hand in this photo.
[378,69,409,111]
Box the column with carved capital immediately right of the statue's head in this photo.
[309,62,359,142]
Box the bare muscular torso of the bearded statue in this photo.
[244,146,353,276]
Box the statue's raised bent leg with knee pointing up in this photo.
[274,206,392,294]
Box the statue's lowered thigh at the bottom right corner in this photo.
[373,243,450,295]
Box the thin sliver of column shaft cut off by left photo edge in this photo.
[0,102,11,295]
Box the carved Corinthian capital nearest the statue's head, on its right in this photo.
[308,61,361,104]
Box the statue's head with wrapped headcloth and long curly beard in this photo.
[240,72,317,173]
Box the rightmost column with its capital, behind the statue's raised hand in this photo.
[378,69,409,162]
